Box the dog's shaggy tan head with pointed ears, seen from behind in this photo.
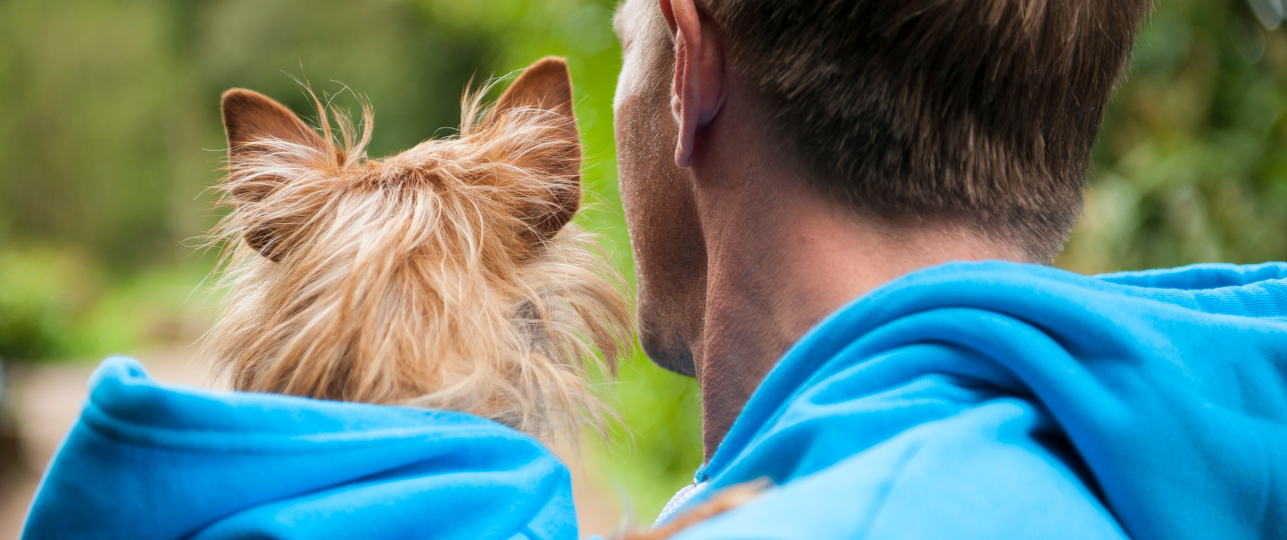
[205,59,634,437]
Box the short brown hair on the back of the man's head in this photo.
[698,0,1152,261]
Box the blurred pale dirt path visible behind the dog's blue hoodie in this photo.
[0,350,620,540]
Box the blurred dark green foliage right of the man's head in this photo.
[1059,0,1287,273]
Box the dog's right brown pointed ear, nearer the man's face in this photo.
[485,57,582,238]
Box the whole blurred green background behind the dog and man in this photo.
[0,0,1287,537]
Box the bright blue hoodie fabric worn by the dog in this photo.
[23,357,577,540]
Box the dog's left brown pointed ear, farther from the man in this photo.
[221,89,327,261]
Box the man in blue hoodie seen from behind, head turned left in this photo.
[615,0,1287,539]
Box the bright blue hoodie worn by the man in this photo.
[678,262,1287,540]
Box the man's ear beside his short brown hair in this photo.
[659,0,727,167]
